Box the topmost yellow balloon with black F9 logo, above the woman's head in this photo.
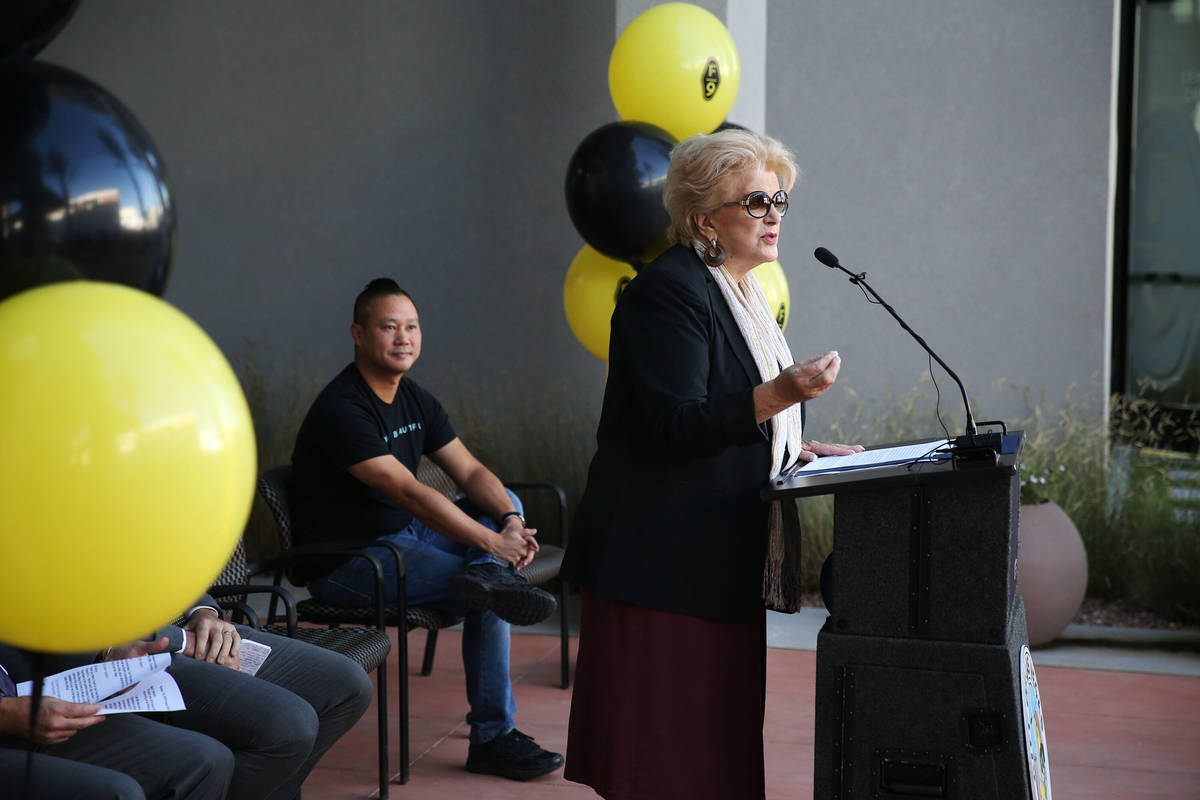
[608,2,742,140]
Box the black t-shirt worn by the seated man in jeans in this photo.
[292,363,455,556]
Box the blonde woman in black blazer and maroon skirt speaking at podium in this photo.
[563,130,857,800]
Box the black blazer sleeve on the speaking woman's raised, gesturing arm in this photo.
[612,268,763,456]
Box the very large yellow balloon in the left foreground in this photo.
[0,281,256,652]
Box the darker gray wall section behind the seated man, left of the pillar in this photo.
[41,0,613,470]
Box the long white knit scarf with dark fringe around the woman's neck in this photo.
[692,241,803,612]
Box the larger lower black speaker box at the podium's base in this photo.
[814,597,1032,800]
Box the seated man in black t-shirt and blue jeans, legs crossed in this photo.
[292,278,563,780]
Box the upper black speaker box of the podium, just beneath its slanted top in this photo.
[830,470,1020,645]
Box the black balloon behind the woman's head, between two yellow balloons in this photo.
[566,120,676,267]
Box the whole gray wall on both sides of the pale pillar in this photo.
[42,0,1112,462]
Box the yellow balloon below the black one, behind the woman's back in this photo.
[563,245,637,361]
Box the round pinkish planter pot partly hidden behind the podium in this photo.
[1016,503,1087,645]
